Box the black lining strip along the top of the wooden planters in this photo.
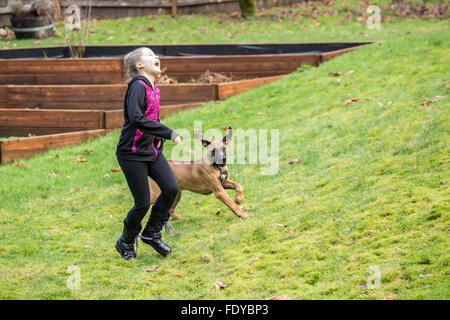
[0,42,370,59]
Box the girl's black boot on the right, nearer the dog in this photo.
[140,211,172,257]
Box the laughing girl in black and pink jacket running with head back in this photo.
[116,48,181,260]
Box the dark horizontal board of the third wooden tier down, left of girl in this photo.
[0,109,104,129]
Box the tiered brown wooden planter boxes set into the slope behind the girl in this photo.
[0,45,374,163]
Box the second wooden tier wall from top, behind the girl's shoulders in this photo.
[0,76,283,110]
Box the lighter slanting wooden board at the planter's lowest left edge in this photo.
[0,129,106,163]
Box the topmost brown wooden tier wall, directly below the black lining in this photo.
[0,54,320,85]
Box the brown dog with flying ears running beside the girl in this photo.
[149,127,248,220]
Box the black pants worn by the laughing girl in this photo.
[117,153,179,233]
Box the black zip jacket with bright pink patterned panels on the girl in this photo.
[116,76,178,161]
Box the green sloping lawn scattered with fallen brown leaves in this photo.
[0,2,450,299]
